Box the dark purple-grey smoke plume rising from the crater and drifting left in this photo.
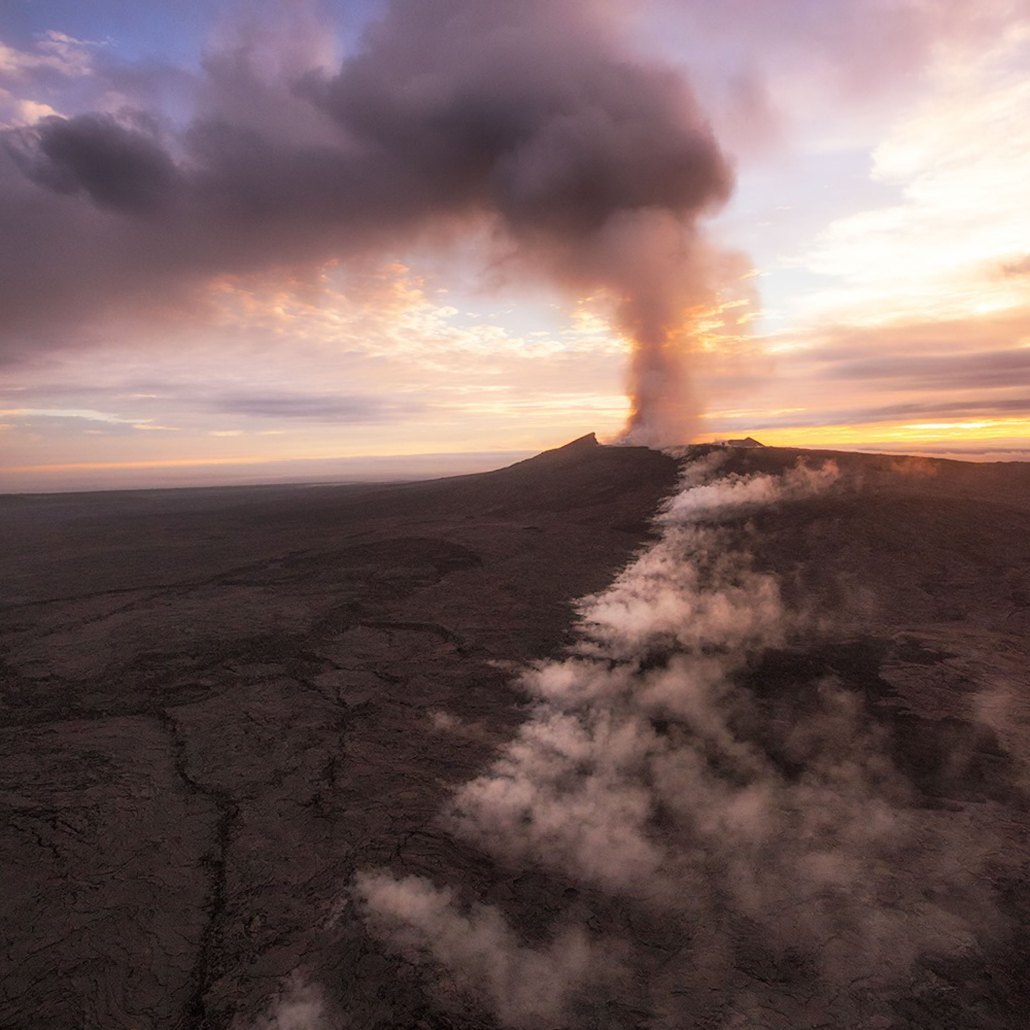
[0,0,731,443]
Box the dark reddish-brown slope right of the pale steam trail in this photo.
[675,448,1030,1030]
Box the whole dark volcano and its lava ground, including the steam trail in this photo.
[0,436,1030,1030]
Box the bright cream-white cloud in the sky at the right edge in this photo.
[778,20,1030,324]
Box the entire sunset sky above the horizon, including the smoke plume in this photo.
[0,0,1030,491]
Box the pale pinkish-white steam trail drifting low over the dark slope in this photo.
[354,461,999,1030]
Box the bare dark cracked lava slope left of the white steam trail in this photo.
[0,436,677,1030]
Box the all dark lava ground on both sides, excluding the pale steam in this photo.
[0,438,1030,1030]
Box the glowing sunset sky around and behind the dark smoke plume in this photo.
[0,0,1030,490]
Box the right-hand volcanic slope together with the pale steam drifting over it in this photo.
[352,447,1030,1030]
